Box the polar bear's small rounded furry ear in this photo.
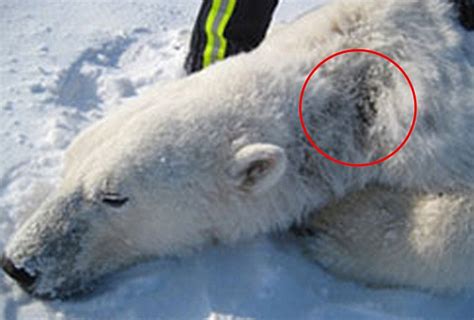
[228,143,287,193]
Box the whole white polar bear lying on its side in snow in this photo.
[2,0,474,298]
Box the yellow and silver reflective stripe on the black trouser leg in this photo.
[202,0,237,68]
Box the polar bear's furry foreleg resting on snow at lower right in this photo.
[305,186,474,292]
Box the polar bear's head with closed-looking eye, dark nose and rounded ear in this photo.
[2,66,324,297]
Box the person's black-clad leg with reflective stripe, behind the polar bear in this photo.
[184,0,278,73]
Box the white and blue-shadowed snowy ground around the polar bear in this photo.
[0,0,474,320]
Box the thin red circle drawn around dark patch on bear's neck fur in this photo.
[298,48,418,167]
